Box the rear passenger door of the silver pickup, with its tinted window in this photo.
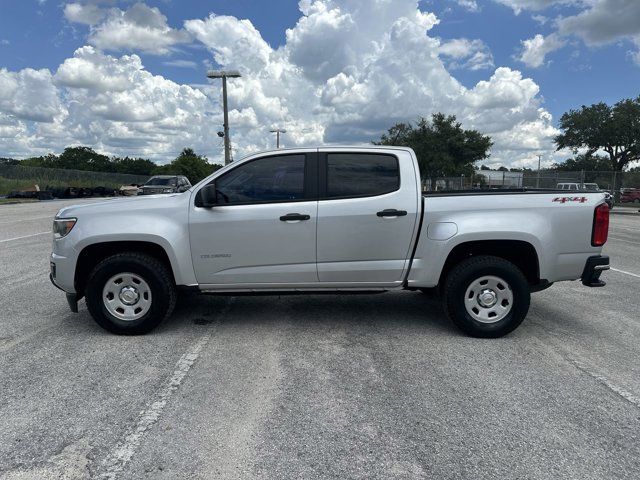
[317,149,420,286]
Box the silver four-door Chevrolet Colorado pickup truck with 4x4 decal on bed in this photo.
[50,147,609,337]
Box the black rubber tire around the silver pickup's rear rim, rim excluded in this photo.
[442,255,531,338]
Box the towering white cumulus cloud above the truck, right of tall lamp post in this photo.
[186,0,557,163]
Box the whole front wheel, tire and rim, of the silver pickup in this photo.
[86,252,176,335]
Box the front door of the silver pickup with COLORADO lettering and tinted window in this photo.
[190,153,318,289]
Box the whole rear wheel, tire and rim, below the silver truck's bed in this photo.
[443,255,531,338]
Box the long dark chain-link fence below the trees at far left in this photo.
[0,165,149,188]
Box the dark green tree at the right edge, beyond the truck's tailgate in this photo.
[555,97,640,172]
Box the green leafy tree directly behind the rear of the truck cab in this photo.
[374,113,493,182]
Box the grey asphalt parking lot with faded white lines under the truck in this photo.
[0,200,640,479]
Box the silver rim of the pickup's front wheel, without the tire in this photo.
[102,272,151,322]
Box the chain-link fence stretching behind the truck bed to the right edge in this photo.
[423,170,640,199]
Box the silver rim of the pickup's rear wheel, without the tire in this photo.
[464,275,513,323]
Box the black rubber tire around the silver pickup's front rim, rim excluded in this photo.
[85,252,176,335]
